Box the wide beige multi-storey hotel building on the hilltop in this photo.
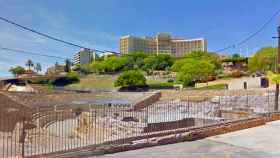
[120,33,207,57]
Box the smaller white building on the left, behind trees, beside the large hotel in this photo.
[73,49,96,65]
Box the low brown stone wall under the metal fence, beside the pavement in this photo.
[30,113,280,158]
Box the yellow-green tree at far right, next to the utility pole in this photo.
[248,47,277,72]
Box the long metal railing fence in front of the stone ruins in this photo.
[0,90,274,158]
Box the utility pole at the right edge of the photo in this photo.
[273,26,280,111]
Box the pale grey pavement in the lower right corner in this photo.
[91,121,280,158]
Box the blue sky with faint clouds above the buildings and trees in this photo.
[0,0,280,77]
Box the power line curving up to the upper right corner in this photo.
[215,9,280,53]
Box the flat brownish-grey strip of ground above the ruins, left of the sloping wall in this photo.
[2,92,150,109]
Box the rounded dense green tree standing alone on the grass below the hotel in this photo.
[115,70,146,87]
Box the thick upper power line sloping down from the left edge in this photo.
[0,16,119,54]
